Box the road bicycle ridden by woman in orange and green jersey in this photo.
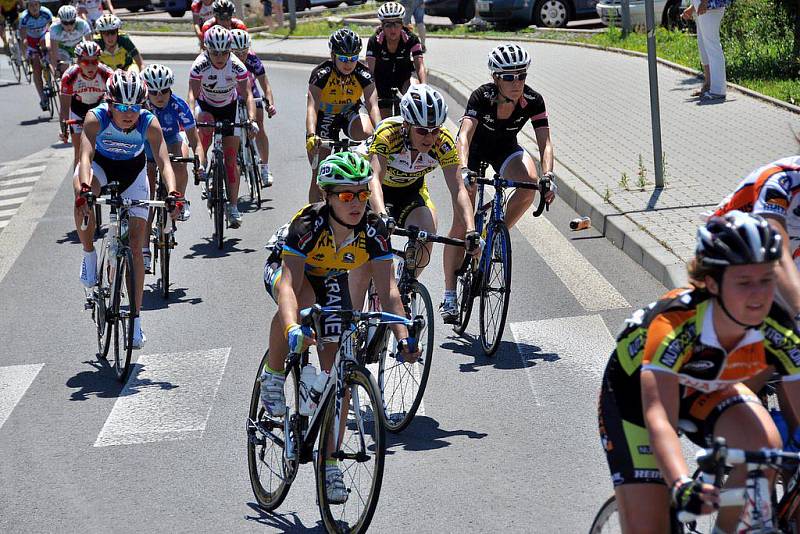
[589,438,800,534]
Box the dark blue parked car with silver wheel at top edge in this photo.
[477,0,597,28]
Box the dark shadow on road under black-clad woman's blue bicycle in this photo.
[442,335,561,373]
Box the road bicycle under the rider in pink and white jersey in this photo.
[197,121,248,250]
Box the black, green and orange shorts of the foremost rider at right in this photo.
[597,370,761,487]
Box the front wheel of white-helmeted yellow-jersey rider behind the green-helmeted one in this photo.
[378,281,434,433]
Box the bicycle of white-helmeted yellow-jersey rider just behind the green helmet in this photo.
[366,226,464,433]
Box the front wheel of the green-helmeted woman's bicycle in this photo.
[316,364,386,533]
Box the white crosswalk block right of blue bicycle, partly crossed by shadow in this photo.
[511,315,614,406]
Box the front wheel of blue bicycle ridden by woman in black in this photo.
[480,223,511,356]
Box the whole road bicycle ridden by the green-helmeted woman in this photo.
[247,305,418,533]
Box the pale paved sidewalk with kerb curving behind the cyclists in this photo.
[135,36,798,286]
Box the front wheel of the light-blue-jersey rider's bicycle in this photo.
[113,249,134,382]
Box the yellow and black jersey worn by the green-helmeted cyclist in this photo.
[268,202,392,276]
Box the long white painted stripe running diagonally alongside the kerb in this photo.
[516,217,630,311]
